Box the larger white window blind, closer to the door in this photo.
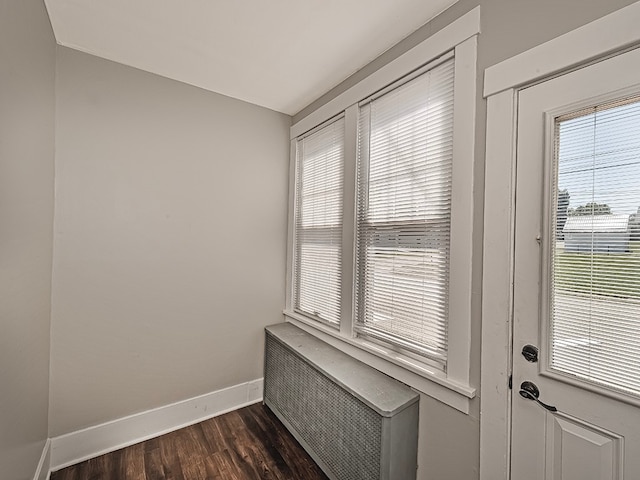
[355,58,454,370]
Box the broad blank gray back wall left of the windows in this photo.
[50,47,291,436]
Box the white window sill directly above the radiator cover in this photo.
[283,310,476,414]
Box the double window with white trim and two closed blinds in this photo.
[284,9,479,412]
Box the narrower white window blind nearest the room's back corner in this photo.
[294,118,344,326]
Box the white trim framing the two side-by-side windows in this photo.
[284,7,480,413]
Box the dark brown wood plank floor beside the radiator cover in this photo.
[51,403,327,480]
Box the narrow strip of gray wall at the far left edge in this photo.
[0,0,55,480]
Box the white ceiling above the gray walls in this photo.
[45,0,457,115]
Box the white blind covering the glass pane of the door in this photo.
[550,97,640,396]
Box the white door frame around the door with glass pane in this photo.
[480,1,640,480]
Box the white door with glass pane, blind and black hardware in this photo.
[511,46,640,480]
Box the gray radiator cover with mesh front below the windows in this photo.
[264,323,419,480]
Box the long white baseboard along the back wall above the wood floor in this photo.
[47,378,263,472]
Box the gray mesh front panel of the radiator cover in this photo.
[265,337,382,480]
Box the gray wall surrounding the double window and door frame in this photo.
[293,0,635,480]
